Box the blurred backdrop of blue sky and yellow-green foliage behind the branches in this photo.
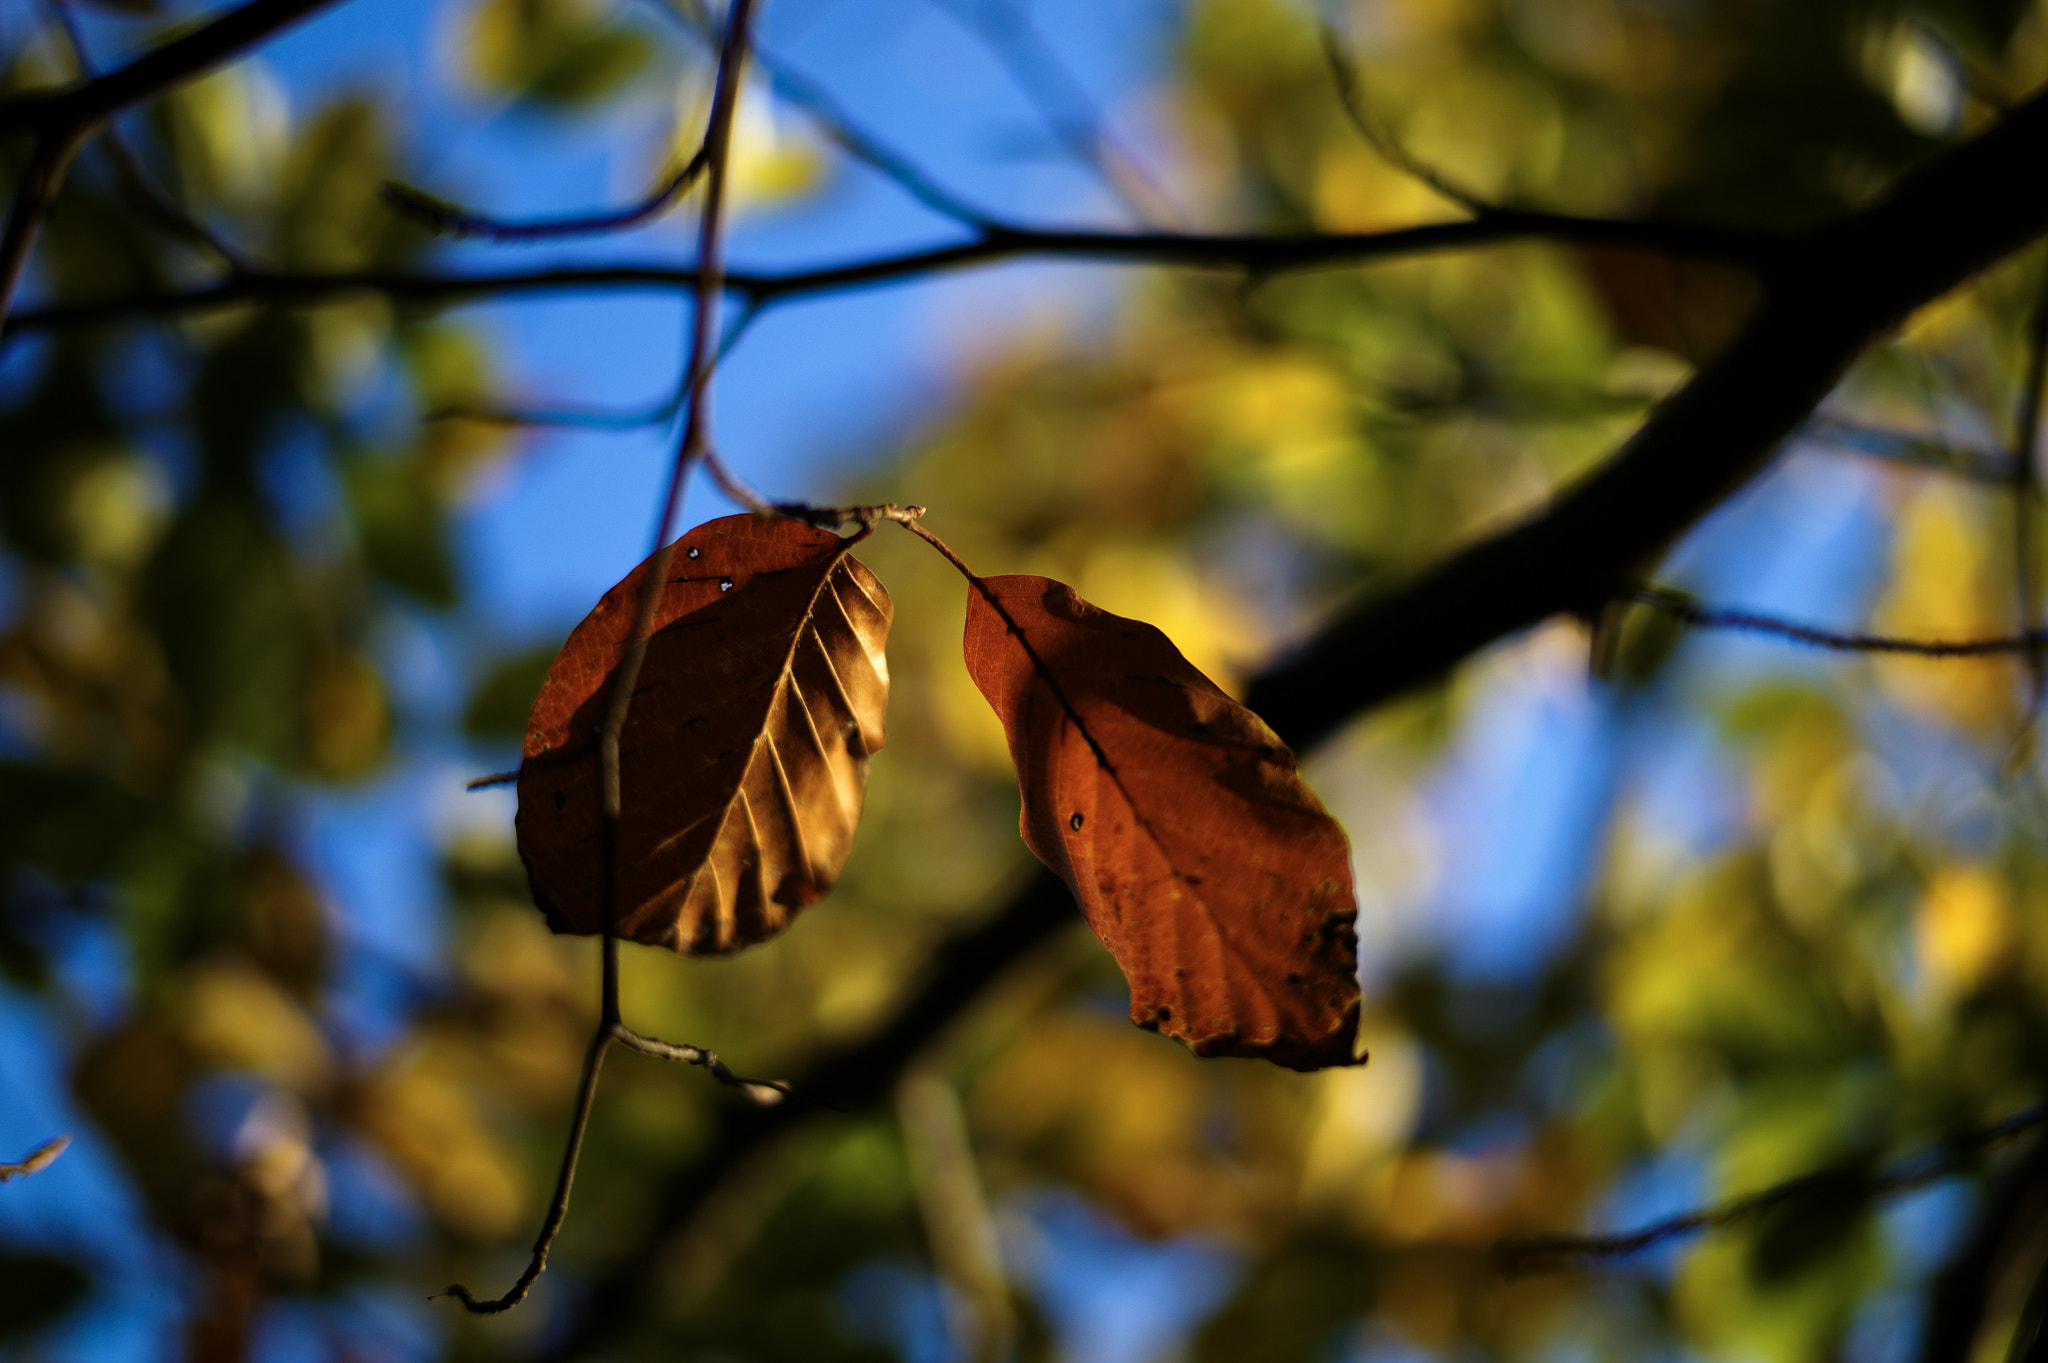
[0,0,2048,1363]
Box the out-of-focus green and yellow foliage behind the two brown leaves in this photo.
[0,0,2048,1363]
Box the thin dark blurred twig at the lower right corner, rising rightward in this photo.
[1493,1107,2048,1273]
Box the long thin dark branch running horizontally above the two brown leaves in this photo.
[6,209,1794,336]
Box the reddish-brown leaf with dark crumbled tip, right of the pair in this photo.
[967,575,1360,1070]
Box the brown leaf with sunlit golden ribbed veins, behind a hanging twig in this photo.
[518,516,893,956]
